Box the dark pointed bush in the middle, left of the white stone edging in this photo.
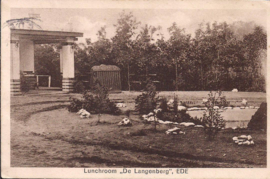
[135,80,158,114]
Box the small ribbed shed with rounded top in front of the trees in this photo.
[91,64,121,92]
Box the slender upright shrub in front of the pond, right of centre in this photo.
[201,92,225,140]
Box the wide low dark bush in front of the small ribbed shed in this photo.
[68,83,120,115]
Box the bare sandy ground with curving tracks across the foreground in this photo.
[11,94,266,167]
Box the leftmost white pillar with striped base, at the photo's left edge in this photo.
[10,36,21,96]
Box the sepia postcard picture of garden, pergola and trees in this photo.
[1,1,268,178]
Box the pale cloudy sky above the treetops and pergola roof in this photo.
[11,8,267,42]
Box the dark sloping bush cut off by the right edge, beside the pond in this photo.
[248,103,267,131]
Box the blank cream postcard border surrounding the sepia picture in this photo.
[1,0,270,178]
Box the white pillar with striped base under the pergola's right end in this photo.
[60,38,75,92]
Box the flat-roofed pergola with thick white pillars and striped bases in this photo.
[10,29,83,95]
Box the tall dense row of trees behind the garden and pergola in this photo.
[32,11,267,91]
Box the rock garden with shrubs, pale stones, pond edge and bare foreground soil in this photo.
[11,81,267,168]
